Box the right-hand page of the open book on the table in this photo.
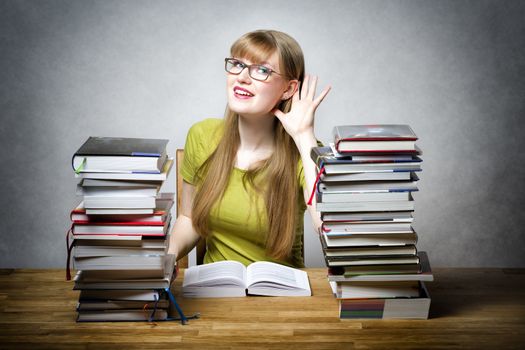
[247,261,310,289]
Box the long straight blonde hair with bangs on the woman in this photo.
[192,30,304,260]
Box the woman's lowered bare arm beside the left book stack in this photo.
[168,181,200,260]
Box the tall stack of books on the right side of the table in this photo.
[311,125,433,319]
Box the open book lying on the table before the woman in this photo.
[182,261,312,298]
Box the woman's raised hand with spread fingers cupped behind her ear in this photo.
[272,75,331,143]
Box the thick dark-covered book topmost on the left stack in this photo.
[72,136,168,174]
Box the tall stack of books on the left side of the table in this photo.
[68,137,176,321]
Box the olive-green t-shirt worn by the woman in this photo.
[181,119,306,267]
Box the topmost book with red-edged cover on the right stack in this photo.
[333,124,417,153]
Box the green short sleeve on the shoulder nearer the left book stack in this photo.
[180,119,222,185]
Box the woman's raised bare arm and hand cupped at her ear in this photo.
[273,75,331,232]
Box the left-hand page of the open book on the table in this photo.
[183,261,246,287]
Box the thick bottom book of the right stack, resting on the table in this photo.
[339,282,430,319]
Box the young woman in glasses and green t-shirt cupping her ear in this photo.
[169,30,330,267]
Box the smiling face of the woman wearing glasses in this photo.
[226,52,289,117]
